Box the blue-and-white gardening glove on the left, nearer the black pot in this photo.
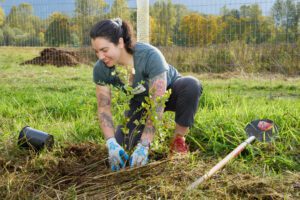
[106,137,129,171]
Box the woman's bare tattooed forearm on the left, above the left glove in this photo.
[96,85,115,140]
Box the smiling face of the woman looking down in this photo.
[92,37,124,67]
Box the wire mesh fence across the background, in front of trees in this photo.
[0,0,300,75]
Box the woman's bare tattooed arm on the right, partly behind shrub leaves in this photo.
[141,72,167,145]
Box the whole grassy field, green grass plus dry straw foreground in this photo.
[0,48,300,199]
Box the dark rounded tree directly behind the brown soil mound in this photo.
[45,13,71,46]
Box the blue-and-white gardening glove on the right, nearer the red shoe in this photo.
[130,143,149,168]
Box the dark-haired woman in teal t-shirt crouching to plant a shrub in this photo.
[90,18,202,171]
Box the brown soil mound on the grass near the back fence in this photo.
[21,48,81,67]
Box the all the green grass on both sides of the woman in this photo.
[0,48,300,196]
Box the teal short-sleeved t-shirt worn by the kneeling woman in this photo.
[93,43,180,100]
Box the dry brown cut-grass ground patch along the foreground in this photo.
[0,143,300,199]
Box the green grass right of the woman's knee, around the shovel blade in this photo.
[191,74,300,171]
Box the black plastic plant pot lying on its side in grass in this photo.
[18,126,54,151]
